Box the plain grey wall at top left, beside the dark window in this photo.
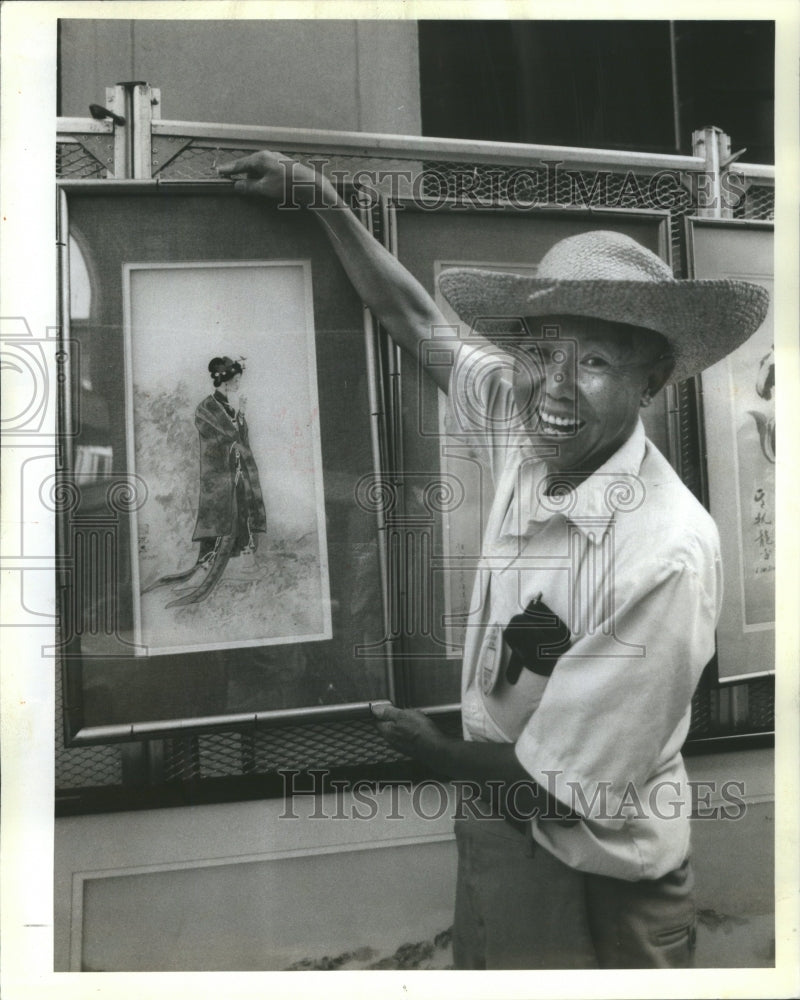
[59,20,420,135]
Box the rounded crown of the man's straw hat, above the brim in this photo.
[536,230,675,281]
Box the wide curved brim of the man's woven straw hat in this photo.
[439,268,769,382]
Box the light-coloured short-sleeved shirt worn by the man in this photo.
[448,348,722,880]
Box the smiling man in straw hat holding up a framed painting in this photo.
[221,153,767,968]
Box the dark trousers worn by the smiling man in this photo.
[453,816,696,969]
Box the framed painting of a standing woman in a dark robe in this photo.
[54,181,391,743]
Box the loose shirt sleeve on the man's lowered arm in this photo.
[515,553,719,811]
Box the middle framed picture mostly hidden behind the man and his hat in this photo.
[392,202,673,705]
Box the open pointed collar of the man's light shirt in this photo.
[501,420,646,540]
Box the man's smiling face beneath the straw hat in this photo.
[512,316,661,474]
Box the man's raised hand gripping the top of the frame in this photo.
[217,149,336,205]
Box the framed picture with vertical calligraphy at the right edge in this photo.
[686,218,775,682]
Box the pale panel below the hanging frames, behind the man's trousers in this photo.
[55,750,774,971]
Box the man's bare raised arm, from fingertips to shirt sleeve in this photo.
[219,150,459,391]
